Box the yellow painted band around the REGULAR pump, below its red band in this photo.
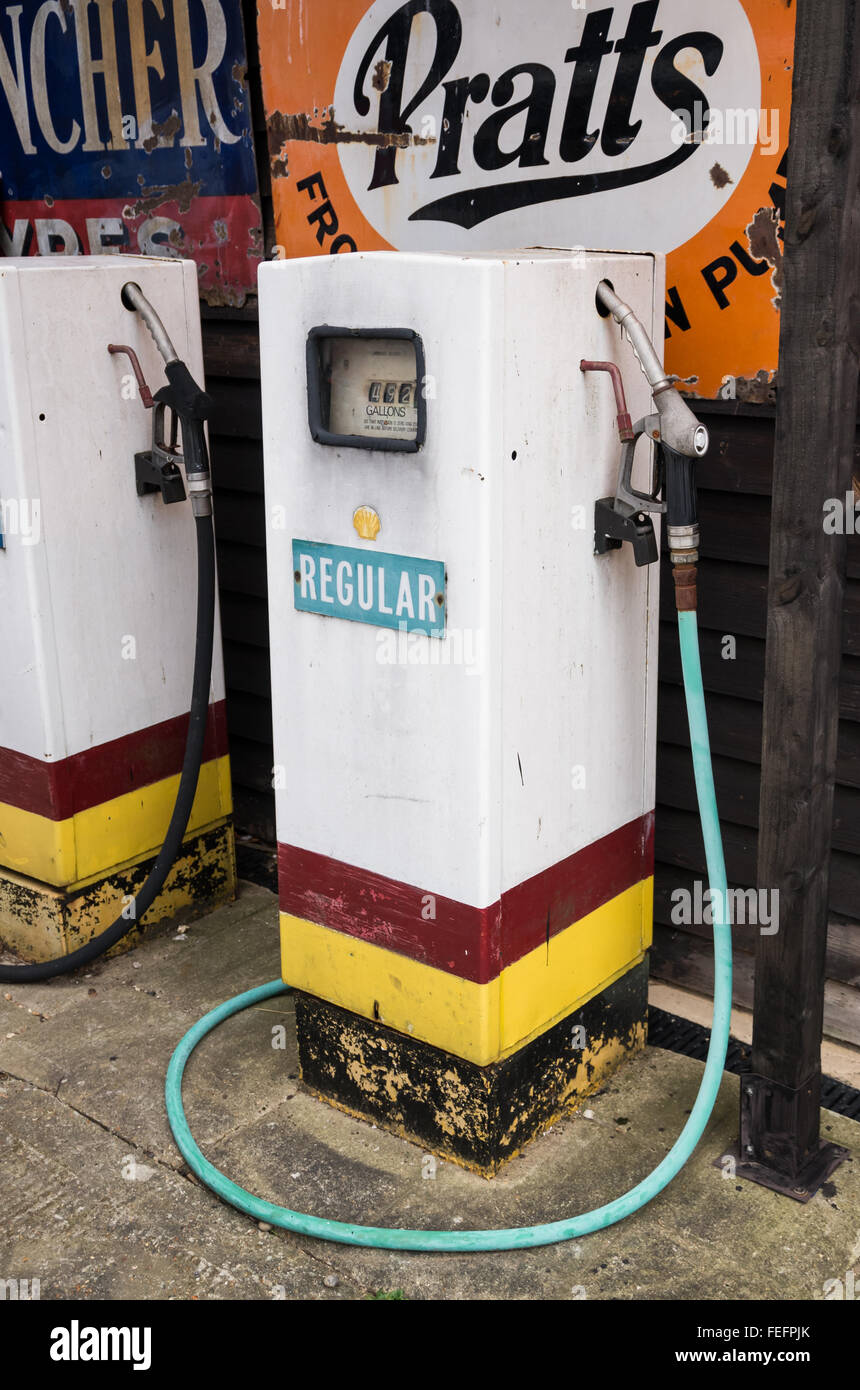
[281,877,653,1066]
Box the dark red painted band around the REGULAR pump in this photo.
[278,812,654,984]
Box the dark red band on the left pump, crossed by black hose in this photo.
[0,701,226,820]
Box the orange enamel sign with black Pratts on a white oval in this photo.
[260,0,793,398]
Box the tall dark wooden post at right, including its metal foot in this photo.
[739,0,860,1201]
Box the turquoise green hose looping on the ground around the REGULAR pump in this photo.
[165,612,732,1252]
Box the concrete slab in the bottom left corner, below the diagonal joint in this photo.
[0,1080,367,1301]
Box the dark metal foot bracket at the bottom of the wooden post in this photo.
[717,1072,852,1202]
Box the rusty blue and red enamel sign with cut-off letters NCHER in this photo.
[0,0,263,304]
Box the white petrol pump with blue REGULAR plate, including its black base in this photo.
[260,250,664,1172]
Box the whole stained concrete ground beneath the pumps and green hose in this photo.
[0,884,860,1301]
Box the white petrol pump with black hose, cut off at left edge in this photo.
[0,256,235,980]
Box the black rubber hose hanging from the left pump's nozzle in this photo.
[0,516,215,984]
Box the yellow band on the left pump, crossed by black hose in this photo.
[0,755,232,890]
